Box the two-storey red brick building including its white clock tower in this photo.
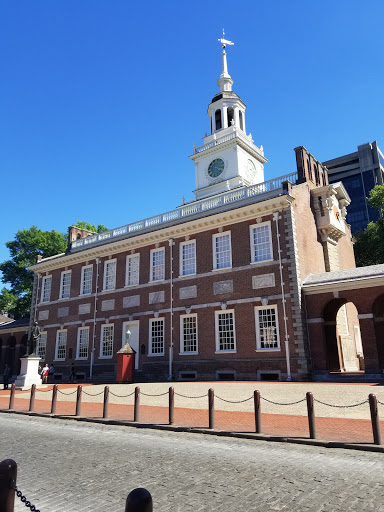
[22,40,364,380]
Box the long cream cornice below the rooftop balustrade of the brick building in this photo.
[29,194,293,273]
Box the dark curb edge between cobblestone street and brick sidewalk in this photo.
[0,409,384,453]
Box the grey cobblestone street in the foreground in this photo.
[0,414,384,512]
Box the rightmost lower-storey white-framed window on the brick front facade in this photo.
[255,306,280,350]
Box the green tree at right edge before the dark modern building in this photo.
[354,185,384,267]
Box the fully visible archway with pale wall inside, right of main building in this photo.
[323,298,364,372]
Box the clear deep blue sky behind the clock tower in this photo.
[0,0,384,278]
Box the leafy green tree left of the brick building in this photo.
[0,226,67,318]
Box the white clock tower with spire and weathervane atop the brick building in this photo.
[190,31,267,199]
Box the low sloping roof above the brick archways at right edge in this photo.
[303,264,384,288]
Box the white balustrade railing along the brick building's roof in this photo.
[71,172,297,249]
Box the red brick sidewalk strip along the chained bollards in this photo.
[0,384,384,443]
